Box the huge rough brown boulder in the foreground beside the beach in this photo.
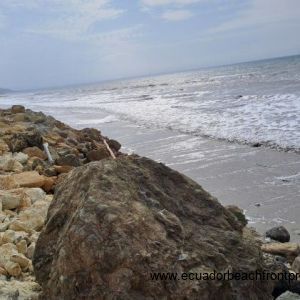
[33,156,272,300]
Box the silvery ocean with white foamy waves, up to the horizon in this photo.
[1,56,300,152]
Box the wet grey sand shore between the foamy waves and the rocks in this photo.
[1,106,300,241]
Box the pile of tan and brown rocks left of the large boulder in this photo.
[0,105,121,299]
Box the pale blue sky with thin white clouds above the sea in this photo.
[0,0,300,90]
